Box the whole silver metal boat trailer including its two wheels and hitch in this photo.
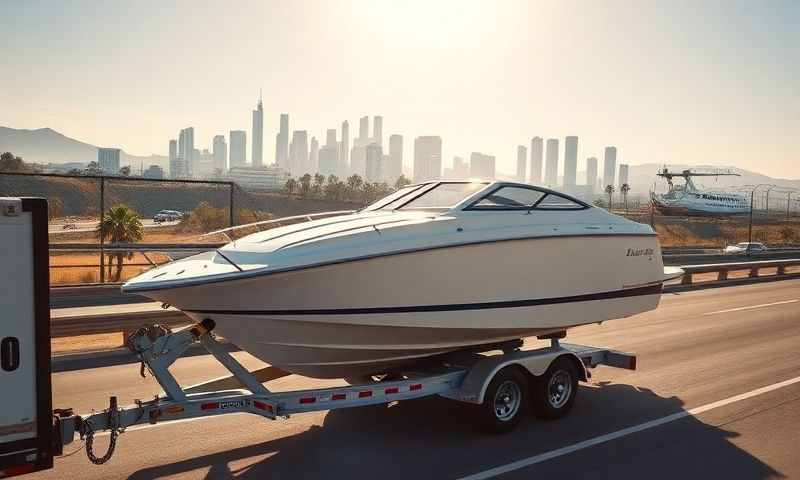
[55,320,636,464]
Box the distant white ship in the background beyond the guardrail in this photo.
[650,168,750,216]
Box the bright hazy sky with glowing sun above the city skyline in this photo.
[0,0,800,178]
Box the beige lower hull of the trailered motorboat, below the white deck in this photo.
[138,235,663,378]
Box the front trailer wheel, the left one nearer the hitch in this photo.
[480,366,528,433]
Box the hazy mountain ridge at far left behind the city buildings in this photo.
[0,127,169,169]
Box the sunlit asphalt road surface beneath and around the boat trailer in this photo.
[30,280,800,480]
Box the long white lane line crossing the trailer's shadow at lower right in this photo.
[460,377,800,480]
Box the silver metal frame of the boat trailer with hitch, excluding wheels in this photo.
[54,319,636,464]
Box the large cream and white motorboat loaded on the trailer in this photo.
[122,181,678,378]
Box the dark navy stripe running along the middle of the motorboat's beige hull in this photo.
[182,283,661,315]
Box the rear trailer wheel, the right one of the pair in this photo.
[531,357,578,420]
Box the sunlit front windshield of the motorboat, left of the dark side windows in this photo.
[366,182,488,211]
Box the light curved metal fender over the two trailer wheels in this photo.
[440,348,588,404]
